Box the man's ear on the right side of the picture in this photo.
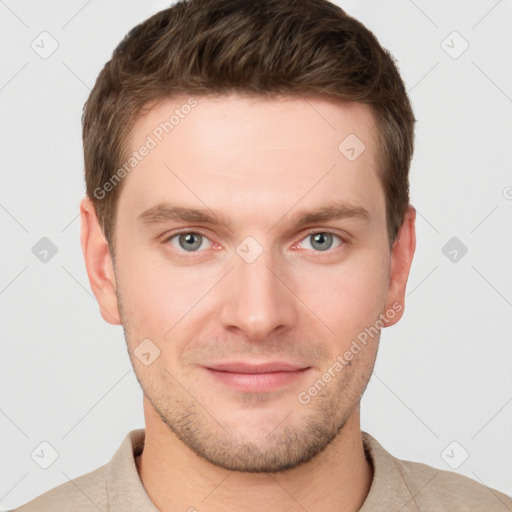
[384,206,416,327]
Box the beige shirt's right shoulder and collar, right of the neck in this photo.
[362,432,512,512]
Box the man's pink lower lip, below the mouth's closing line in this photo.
[206,368,309,392]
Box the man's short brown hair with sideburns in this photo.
[82,0,415,254]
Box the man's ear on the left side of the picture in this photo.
[80,197,121,325]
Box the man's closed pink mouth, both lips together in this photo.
[203,361,311,393]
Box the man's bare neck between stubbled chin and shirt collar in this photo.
[136,397,373,512]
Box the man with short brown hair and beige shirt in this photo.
[14,0,512,512]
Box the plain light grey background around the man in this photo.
[0,0,512,509]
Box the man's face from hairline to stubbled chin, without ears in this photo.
[82,95,412,472]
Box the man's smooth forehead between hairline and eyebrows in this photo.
[119,94,384,228]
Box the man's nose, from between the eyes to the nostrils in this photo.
[220,250,299,342]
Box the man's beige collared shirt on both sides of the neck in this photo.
[16,429,512,512]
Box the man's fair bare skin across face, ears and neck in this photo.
[81,94,415,512]
